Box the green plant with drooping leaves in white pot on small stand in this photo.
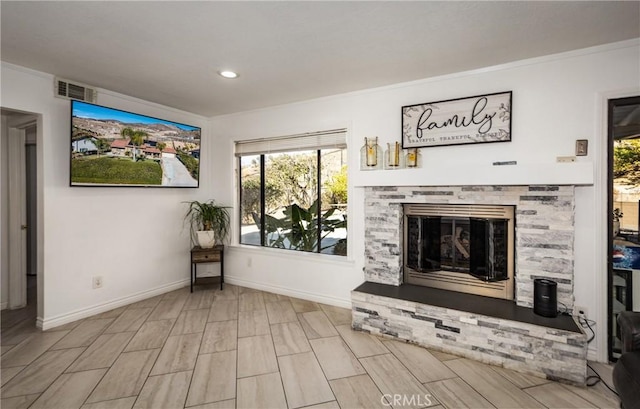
[184,200,230,248]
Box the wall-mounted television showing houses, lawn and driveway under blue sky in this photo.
[70,101,201,187]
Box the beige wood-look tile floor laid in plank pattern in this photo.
[1,285,619,409]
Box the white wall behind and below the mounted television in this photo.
[1,63,218,328]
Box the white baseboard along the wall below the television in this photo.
[41,280,190,331]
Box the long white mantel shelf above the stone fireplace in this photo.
[350,162,594,187]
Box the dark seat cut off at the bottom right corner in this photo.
[613,311,640,409]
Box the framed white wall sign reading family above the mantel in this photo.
[402,91,511,149]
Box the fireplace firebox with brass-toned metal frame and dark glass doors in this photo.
[403,204,515,300]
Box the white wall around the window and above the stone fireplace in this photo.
[212,40,640,360]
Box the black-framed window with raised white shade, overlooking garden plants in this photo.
[236,130,347,256]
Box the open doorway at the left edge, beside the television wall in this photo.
[0,108,42,332]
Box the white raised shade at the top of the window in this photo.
[235,129,347,156]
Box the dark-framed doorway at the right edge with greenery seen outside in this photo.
[607,96,640,361]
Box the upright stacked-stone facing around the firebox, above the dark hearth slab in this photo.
[364,186,574,310]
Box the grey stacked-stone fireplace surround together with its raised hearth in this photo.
[352,185,587,384]
